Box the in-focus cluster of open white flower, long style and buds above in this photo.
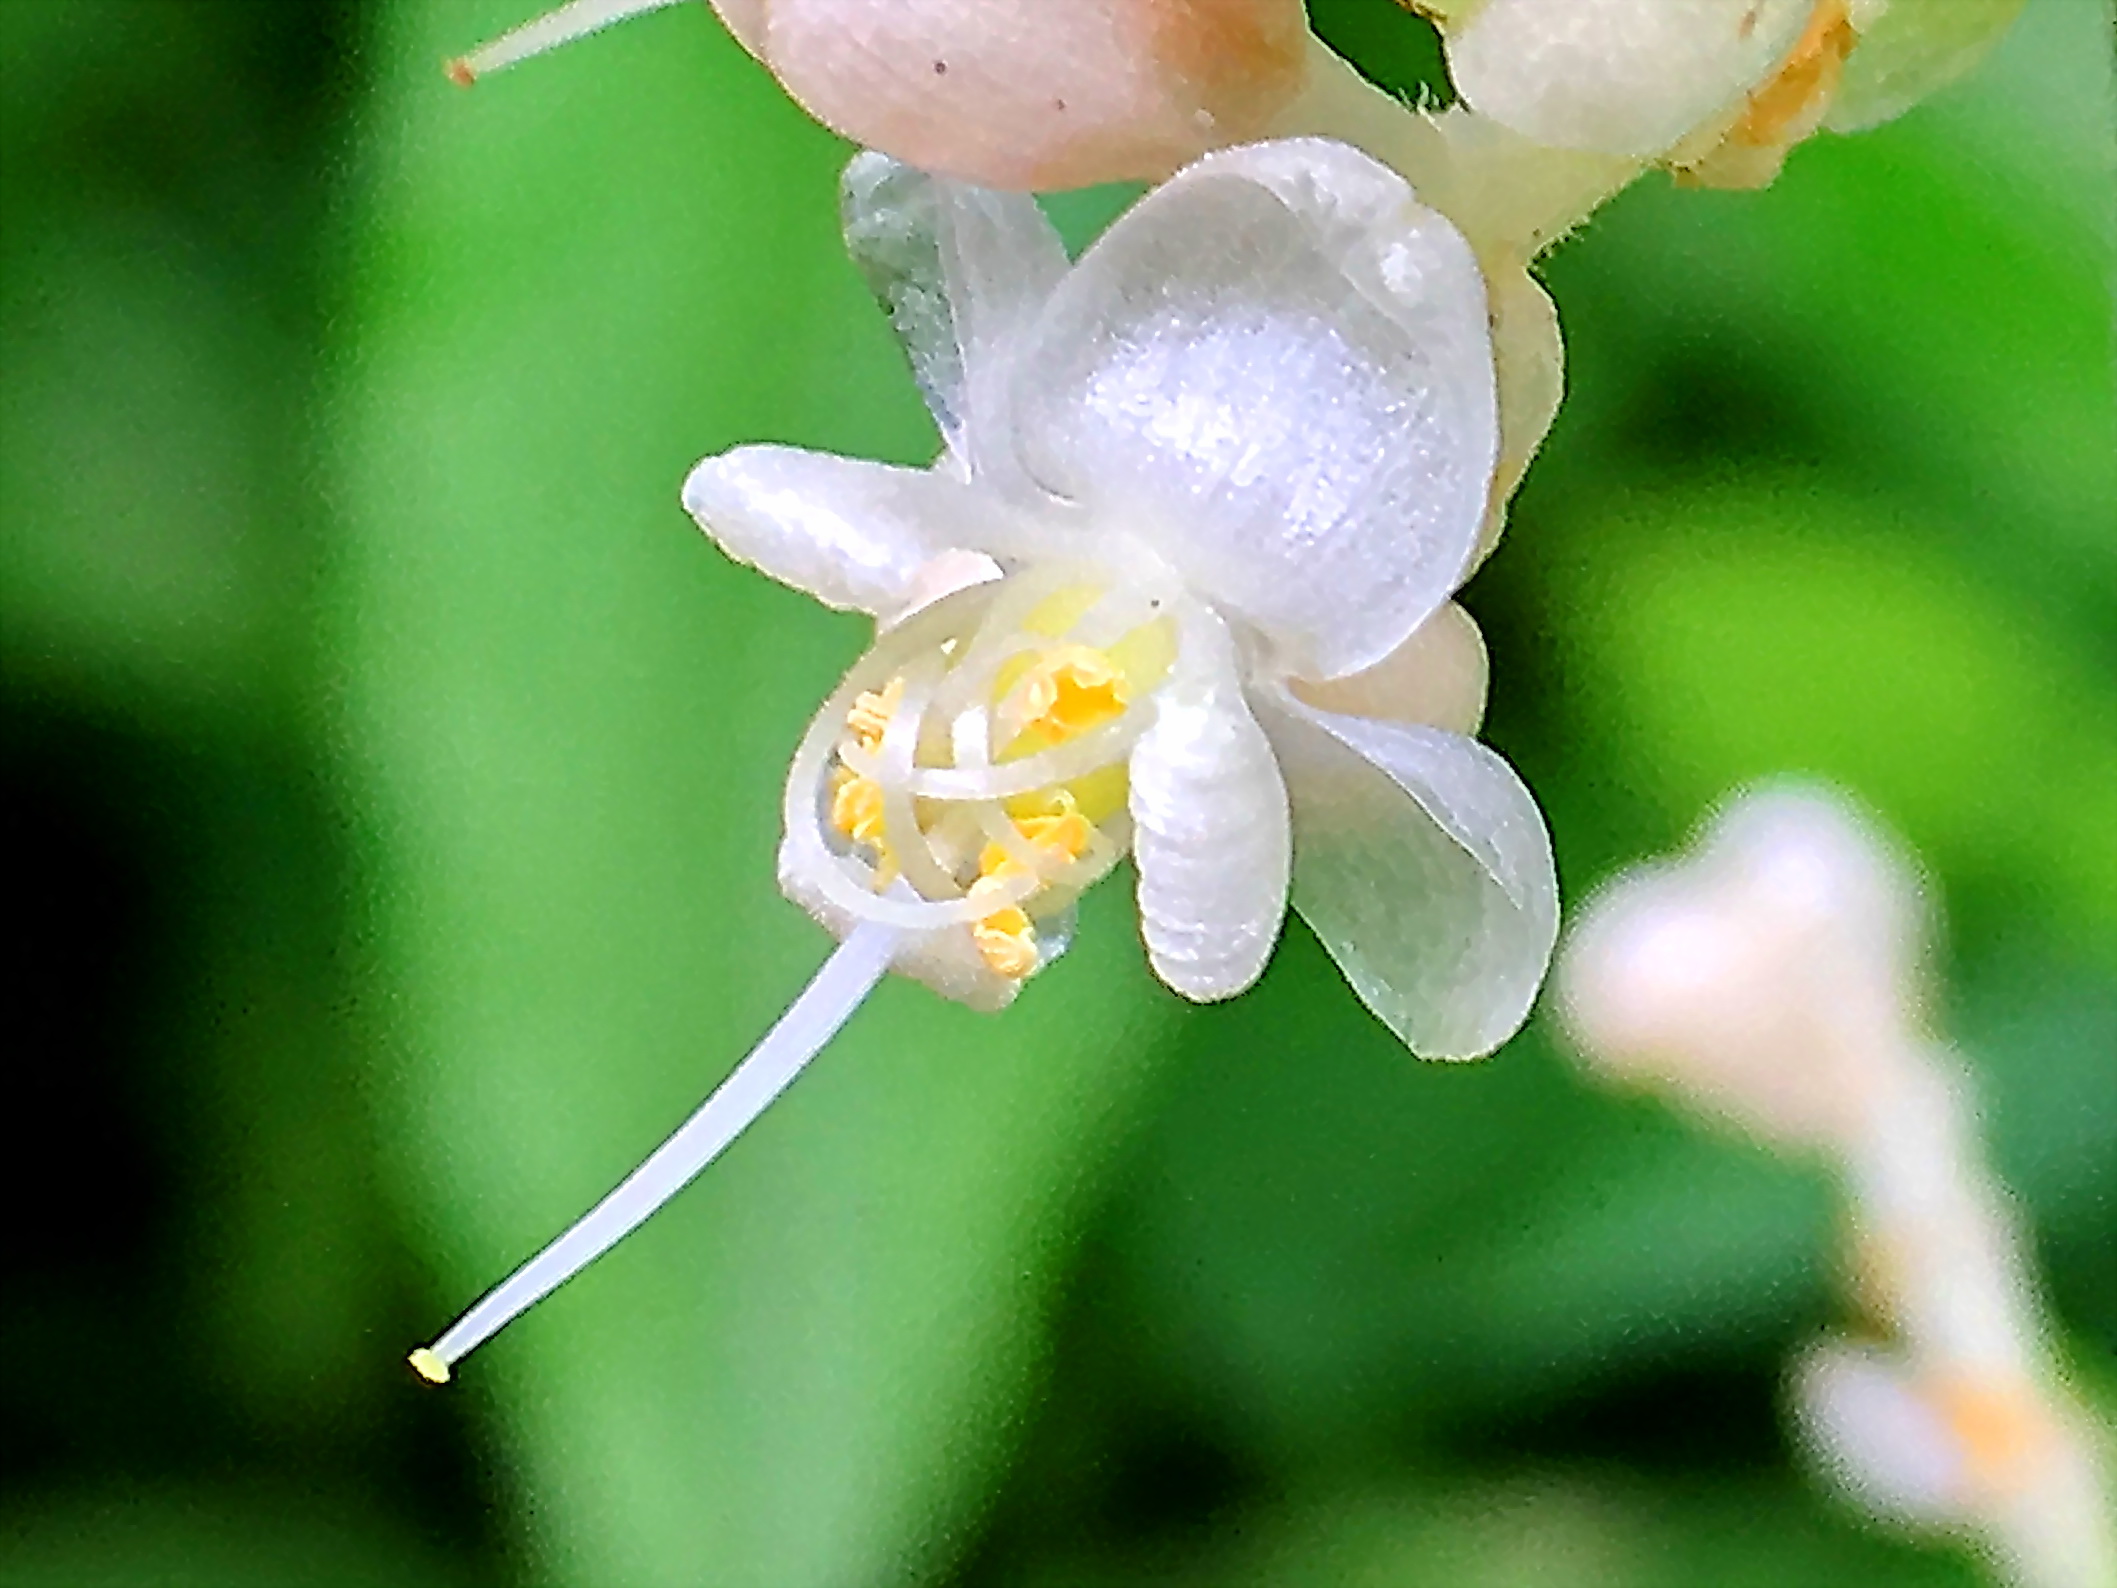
[415,0,2018,1431]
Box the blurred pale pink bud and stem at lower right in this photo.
[1560,790,2117,1588]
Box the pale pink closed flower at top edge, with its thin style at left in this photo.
[455,0,1308,191]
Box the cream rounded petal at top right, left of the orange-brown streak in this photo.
[1448,0,1812,159]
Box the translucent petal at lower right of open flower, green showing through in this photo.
[1264,697,1558,1059]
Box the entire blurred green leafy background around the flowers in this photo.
[0,0,2117,1588]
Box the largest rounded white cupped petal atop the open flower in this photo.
[1012,140,1499,678]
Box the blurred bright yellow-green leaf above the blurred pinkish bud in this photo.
[1562,485,2117,953]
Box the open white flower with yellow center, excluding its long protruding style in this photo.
[684,142,1556,1057]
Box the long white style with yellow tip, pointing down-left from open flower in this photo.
[411,921,902,1385]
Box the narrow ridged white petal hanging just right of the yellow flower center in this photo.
[1130,626,1289,1004]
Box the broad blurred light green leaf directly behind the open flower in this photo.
[334,0,1169,1586]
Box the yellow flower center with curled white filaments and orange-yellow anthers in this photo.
[788,570,1177,980]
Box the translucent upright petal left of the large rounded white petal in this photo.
[840,152,1067,466]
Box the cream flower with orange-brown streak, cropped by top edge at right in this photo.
[1410,0,2022,186]
